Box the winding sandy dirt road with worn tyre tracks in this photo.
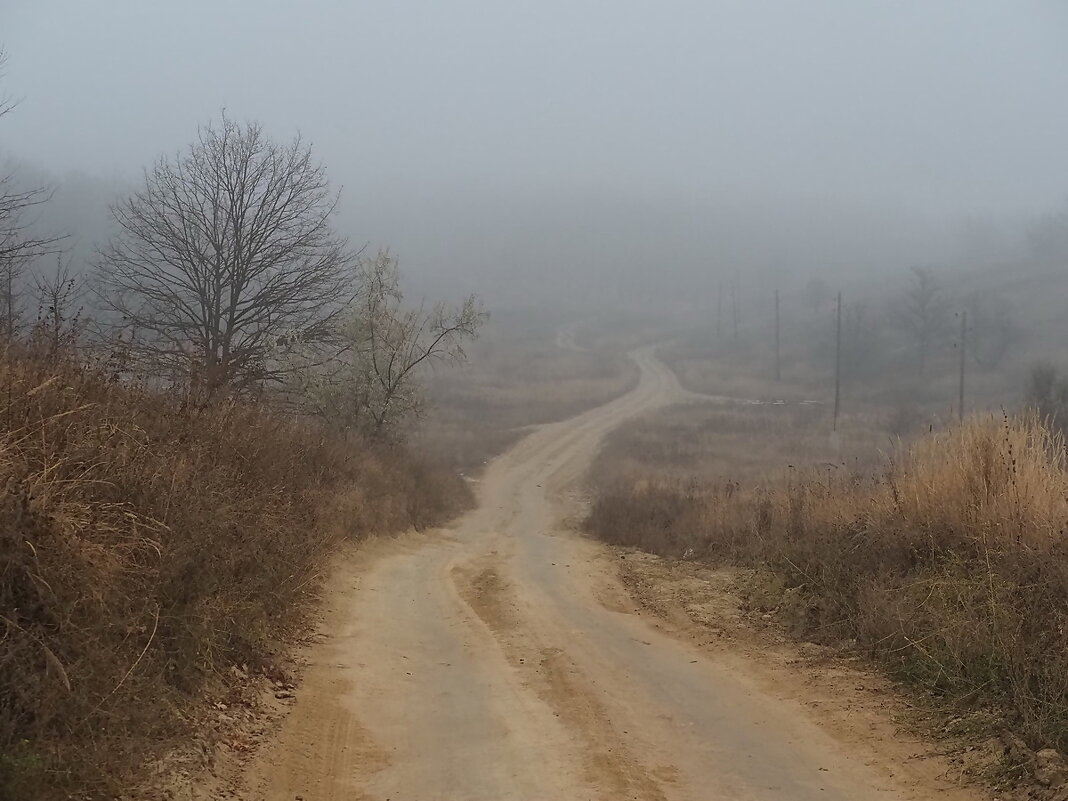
[247,350,972,801]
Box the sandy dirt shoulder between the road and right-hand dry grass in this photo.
[602,548,999,801]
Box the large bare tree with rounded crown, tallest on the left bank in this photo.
[97,115,356,397]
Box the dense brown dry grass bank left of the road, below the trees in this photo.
[0,356,466,800]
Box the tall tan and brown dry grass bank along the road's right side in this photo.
[587,418,1068,749]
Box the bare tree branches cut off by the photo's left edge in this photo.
[0,49,61,342]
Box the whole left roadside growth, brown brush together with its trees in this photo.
[0,64,476,801]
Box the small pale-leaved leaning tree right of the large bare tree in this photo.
[300,252,487,436]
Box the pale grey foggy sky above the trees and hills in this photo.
[0,0,1068,307]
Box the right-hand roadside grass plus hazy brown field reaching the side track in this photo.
[586,358,1068,764]
